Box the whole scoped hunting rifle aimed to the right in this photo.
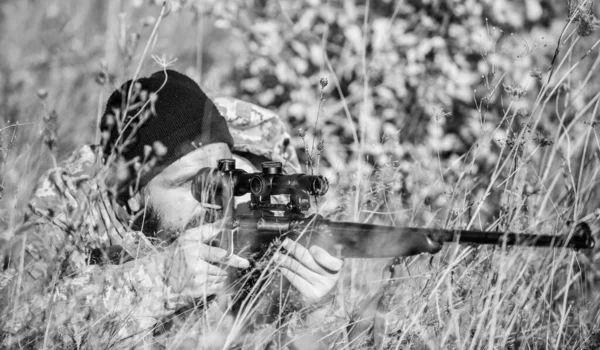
[192,159,595,258]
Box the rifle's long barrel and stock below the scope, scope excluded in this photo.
[233,216,594,258]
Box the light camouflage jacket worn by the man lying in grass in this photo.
[0,98,300,348]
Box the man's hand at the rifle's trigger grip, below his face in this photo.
[165,221,250,298]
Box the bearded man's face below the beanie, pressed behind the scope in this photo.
[142,143,232,238]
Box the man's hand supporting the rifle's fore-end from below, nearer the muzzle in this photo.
[273,239,344,302]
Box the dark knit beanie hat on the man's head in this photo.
[100,70,233,200]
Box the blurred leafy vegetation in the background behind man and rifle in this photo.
[0,0,599,232]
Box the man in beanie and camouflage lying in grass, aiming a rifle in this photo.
[0,70,342,348]
